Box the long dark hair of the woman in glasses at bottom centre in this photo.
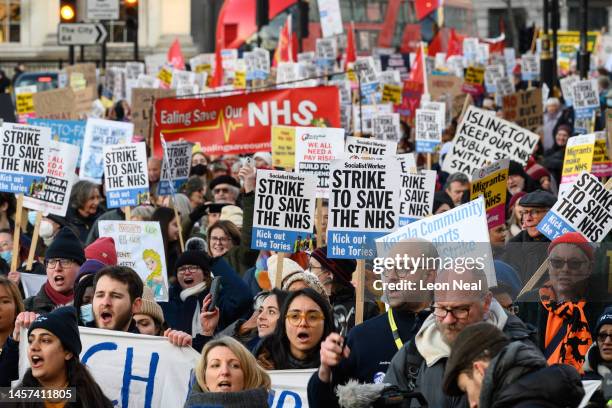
[260,288,334,370]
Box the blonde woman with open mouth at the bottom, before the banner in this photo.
[185,336,271,408]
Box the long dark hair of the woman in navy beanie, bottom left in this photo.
[19,356,113,408]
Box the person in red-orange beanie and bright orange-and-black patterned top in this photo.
[518,232,607,373]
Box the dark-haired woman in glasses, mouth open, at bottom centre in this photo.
[253,288,333,370]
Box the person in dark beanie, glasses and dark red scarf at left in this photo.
[24,227,85,313]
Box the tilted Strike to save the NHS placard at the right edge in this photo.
[538,171,612,242]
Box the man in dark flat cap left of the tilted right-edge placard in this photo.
[502,190,557,284]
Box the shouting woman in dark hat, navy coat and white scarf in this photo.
[160,248,251,350]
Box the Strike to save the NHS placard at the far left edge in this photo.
[0,122,51,194]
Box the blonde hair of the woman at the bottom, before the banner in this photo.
[196,336,271,391]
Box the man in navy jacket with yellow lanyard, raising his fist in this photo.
[308,239,438,407]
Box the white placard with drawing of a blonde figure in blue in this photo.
[98,220,168,302]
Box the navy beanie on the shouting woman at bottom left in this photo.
[28,306,82,359]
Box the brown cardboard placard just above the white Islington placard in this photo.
[502,88,544,132]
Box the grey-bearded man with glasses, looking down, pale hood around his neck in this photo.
[384,268,533,407]
